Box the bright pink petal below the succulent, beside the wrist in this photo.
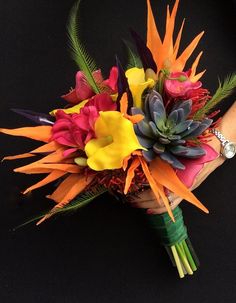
[176,144,219,188]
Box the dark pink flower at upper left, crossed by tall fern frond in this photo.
[62,67,118,105]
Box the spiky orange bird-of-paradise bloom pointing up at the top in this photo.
[147,0,205,82]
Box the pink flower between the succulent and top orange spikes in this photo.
[164,71,202,98]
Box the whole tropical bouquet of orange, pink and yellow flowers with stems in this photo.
[0,0,236,277]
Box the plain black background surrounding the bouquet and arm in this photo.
[0,0,236,303]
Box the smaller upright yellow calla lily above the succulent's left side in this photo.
[125,67,155,108]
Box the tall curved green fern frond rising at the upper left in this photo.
[67,0,100,94]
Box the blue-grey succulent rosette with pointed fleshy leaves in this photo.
[131,90,213,170]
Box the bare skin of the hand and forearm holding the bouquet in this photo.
[131,101,236,214]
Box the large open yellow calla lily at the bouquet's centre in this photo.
[85,111,144,171]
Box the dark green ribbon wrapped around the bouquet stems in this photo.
[148,206,188,246]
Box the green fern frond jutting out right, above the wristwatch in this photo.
[193,73,236,120]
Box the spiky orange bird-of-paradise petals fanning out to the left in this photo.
[0,126,94,221]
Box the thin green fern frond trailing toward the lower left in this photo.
[14,185,108,230]
